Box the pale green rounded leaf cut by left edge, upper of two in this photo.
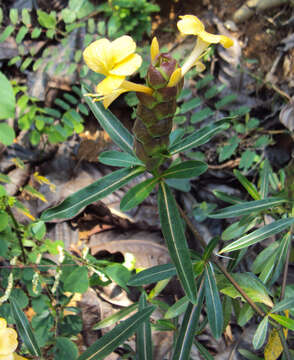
[0,72,15,119]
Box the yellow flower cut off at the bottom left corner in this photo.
[0,318,26,360]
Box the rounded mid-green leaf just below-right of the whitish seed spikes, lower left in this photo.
[63,266,89,294]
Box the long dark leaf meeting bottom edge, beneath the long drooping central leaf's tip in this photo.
[172,283,204,360]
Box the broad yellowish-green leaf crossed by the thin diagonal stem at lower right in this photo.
[218,273,273,307]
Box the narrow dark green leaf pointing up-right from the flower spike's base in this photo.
[169,123,229,155]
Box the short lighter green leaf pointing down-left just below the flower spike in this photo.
[120,178,159,211]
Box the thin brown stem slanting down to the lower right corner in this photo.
[177,203,292,360]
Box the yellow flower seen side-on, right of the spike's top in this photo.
[177,15,234,75]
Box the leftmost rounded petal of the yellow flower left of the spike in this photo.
[83,39,111,76]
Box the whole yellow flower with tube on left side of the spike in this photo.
[82,35,151,108]
